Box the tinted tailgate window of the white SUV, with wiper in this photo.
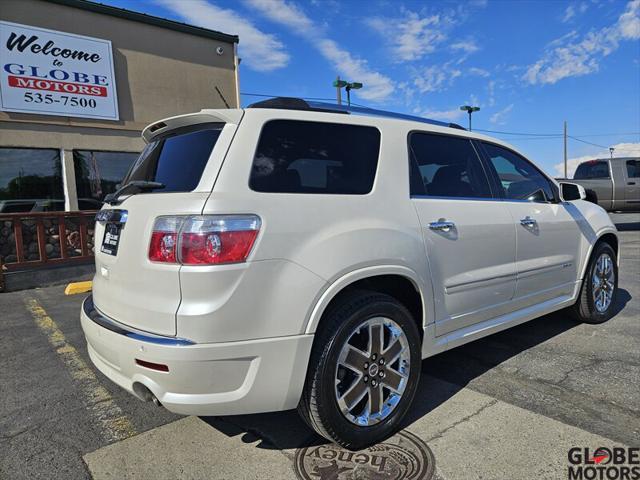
[122,123,224,192]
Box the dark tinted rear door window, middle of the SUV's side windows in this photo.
[409,132,491,197]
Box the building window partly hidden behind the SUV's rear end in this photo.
[73,150,139,210]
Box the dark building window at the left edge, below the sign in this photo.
[0,148,64,213]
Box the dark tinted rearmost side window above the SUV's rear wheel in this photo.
[249,120,380,195]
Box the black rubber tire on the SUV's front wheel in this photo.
[572,242,618,324]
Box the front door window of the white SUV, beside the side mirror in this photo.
[483,143,555,202]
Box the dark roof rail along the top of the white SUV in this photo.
[247,97,466,130]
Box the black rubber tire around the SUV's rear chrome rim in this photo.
[298,290,422,450]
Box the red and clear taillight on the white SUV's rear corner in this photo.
[149,215,260,265]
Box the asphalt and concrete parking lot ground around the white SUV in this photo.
[0,214,640,480]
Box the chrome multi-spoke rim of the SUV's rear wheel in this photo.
[335,317,411,426]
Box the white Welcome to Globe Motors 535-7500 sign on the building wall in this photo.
[0,22,119,120]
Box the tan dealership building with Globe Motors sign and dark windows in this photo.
[0,0,240,213]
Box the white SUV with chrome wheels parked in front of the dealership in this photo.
[81,99,618,449]
